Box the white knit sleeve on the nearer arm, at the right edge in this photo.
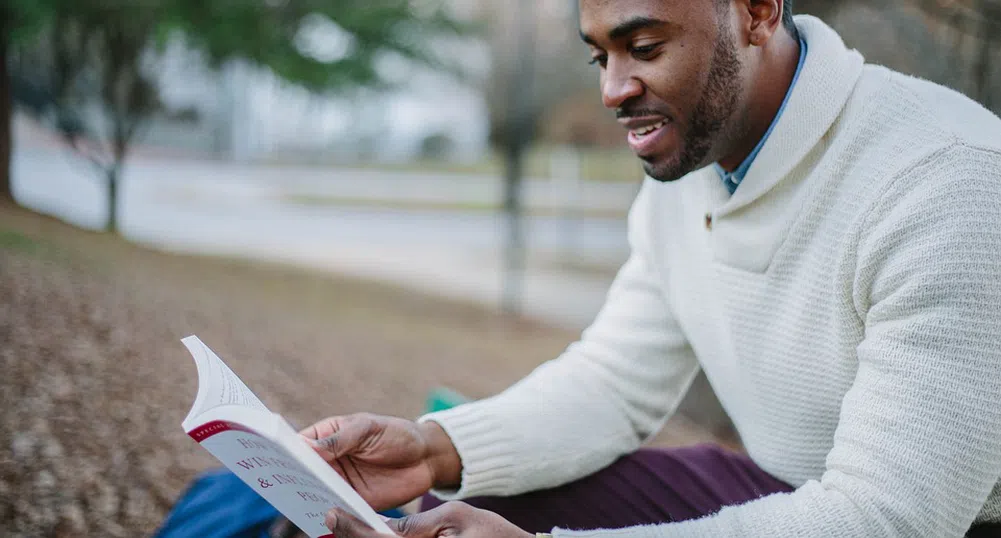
[555,144,1001,538]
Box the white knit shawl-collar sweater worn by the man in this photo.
[424,17,1001,538]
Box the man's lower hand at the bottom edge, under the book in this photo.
[326,503,535,538]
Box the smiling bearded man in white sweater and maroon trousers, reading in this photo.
[303,0,1001,538]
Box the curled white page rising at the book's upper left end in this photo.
[181,337,268,428]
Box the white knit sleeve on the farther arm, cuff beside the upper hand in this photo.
[420,180,699,499]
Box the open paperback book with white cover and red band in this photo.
[181,337,394,538]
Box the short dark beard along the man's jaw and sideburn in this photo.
[643,16,741,181]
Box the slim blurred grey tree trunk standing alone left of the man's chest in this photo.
[502,140,525,314]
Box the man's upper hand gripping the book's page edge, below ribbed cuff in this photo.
[300,414,461,510]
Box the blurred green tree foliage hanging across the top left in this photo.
[4,0,469,91]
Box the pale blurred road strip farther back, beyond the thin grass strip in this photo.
[13,114,640,218]
